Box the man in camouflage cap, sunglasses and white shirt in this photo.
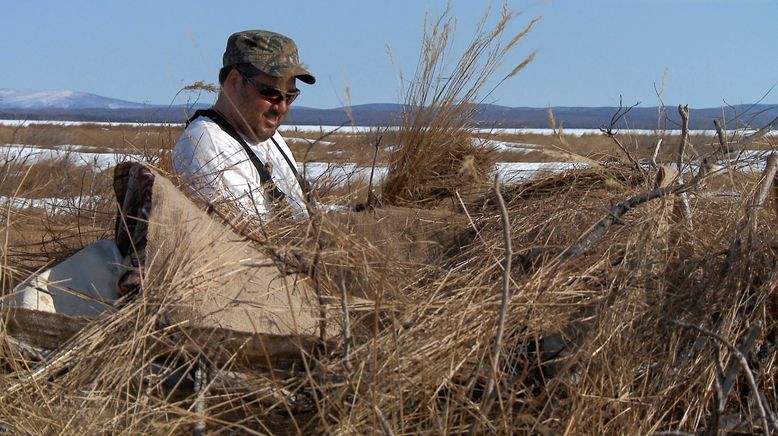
[173,30,316,218]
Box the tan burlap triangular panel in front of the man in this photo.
[136,165,335,335]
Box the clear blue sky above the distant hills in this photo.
[0,0,778,108]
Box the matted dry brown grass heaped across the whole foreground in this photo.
[0,156,778,434]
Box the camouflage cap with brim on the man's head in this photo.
[223,30,316,85]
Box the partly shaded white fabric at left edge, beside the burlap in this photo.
[4,241,125,317]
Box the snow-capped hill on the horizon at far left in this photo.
[0,89,145,110]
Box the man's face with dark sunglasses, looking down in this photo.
[233,71,299,141]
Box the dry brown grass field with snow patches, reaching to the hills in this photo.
[0,116,778,434]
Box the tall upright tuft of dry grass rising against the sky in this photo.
[383,7,537,205]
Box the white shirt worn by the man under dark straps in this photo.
[173,116,308,218]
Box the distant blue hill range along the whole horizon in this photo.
[0,89,778,129]
